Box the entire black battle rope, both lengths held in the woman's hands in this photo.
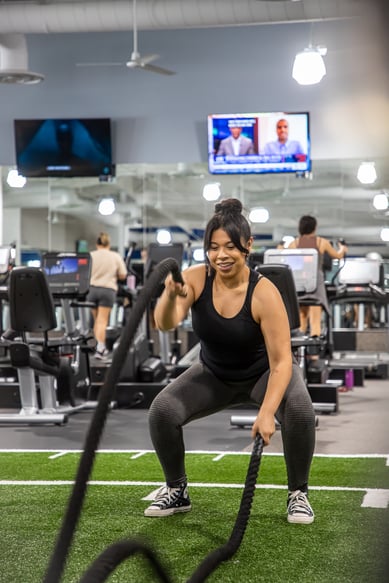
[43,258,263,583]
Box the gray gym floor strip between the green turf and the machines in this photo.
[0,379,389,456]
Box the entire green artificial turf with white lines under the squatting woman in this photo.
[0,453,389,583]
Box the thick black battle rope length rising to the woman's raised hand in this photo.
[43,258,182,583]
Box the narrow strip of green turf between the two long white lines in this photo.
[0,452,389,488]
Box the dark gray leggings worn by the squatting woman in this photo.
[149,363,315,490]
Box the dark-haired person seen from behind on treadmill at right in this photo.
[288,215,347,337]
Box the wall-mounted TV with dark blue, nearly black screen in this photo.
[14,118,113,178]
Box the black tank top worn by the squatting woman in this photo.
[192,269,269,381]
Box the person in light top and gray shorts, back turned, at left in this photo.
[86,233,127,359]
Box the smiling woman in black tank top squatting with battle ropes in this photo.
[145,199,315,524]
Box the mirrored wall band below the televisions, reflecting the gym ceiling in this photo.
[2,159,389,264]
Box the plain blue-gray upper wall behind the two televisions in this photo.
[0,20,389,165]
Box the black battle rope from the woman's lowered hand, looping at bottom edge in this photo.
[76,435,263,583]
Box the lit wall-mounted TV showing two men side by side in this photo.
[208,111,311,174]
